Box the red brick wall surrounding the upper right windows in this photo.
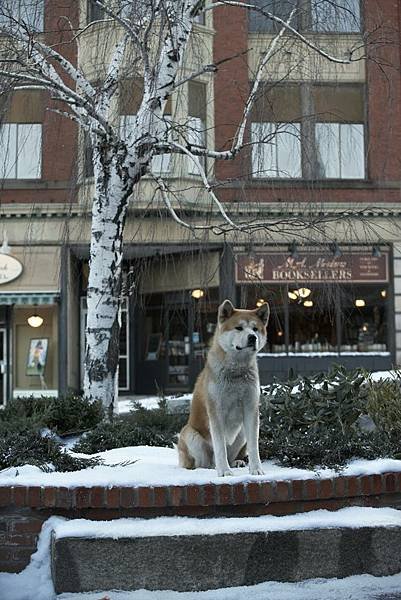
[214,0,401,205]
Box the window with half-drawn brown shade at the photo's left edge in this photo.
[0,89,44,179]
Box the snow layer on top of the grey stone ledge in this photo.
[54,506,401,540]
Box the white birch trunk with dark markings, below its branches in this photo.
[84,140,129,418]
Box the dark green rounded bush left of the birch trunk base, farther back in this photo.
[0,393,104,435]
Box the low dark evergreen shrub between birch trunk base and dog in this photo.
[74,400,188,454]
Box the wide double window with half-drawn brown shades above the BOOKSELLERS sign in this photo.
[251,83,365,179]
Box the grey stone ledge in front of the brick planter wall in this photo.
[52,509,401,594]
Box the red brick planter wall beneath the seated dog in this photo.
[0,473,401,572]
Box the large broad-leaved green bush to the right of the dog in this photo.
[260,367,401,469]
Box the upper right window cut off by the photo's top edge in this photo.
[248,0,361,33]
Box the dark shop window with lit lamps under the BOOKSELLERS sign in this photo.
[239,283,389,354]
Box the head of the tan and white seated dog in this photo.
[218,300,270,355]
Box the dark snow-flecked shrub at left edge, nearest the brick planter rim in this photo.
[0,429,102,471]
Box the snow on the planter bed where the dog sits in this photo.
[0,446,401,488]
